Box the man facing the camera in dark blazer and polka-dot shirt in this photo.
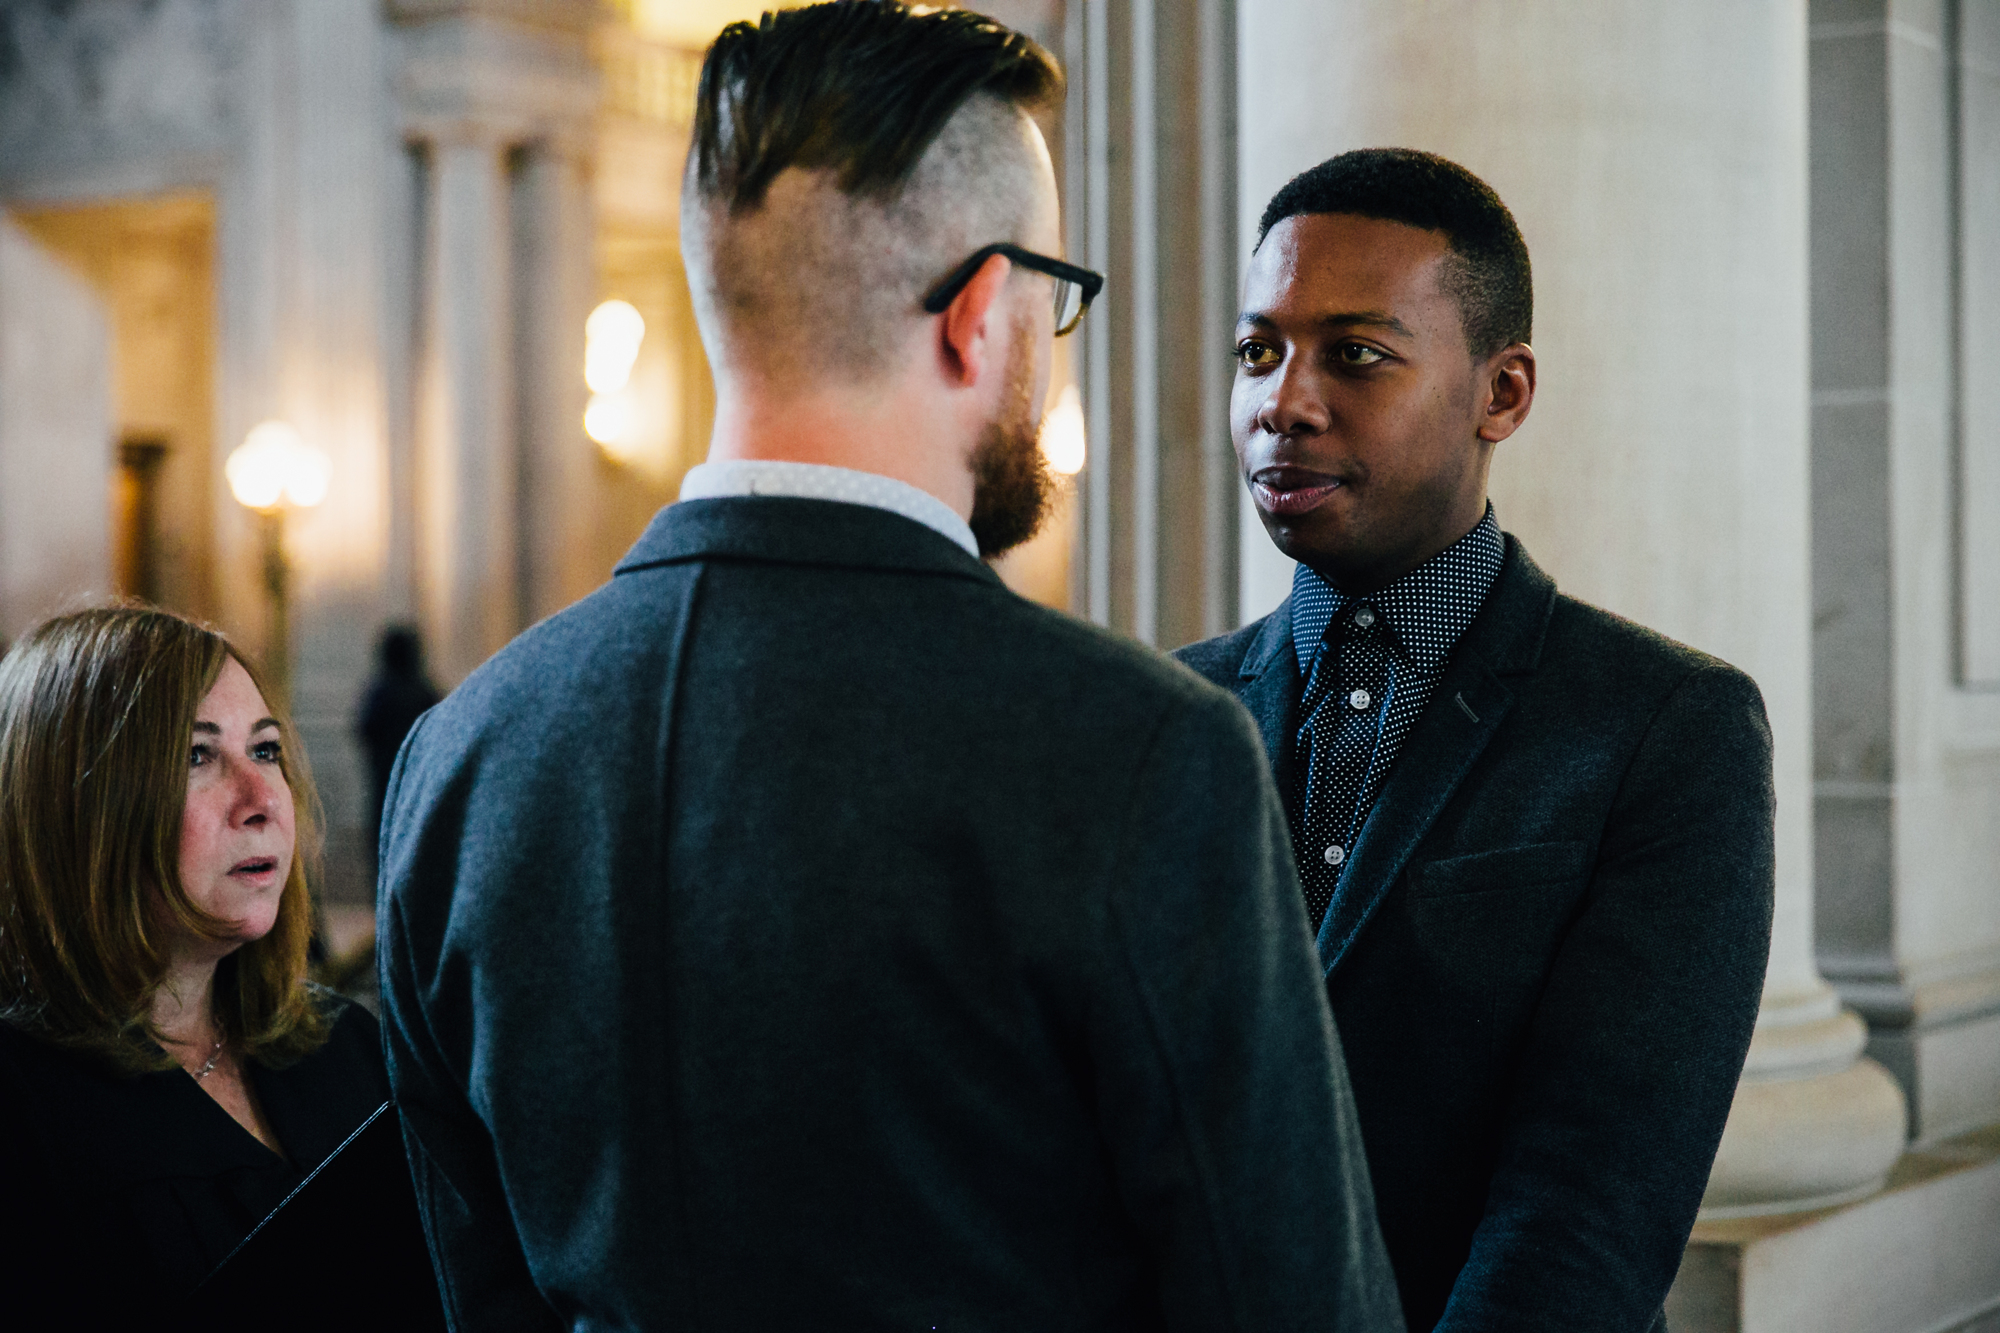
[1180,150,1772,1333]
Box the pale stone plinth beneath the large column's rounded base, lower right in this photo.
[1666,1125,2000,1333]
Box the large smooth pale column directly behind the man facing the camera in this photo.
[1238,0,1904,1217]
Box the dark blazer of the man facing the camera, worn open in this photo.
[1180,536,1772,1333]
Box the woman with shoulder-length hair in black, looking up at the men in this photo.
[0,606,440,1327]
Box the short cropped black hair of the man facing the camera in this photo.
[1256,148,1534,356]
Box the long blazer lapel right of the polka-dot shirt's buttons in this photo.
[1318,536,1556,977]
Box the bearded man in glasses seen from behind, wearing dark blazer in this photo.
[380,4,1402,1333]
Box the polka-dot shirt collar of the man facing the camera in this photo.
[1292,500,1506,681]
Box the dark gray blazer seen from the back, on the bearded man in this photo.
[380,498,1402,1333]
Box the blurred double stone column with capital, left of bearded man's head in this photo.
[388,0,598,668]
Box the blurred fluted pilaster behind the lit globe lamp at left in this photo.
[227,0,398,901]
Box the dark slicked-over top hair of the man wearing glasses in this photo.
[694,0,1062,212]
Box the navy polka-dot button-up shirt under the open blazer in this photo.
[1284,504,1506,931]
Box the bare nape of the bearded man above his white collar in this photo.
[708,384,972,518]
